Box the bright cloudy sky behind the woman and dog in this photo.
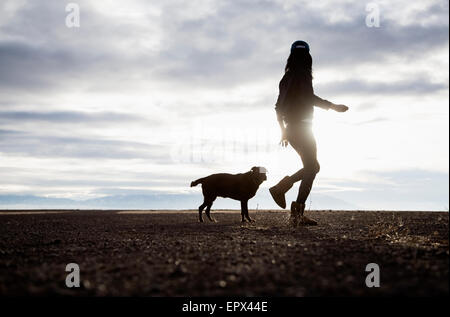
[0,0,449,210]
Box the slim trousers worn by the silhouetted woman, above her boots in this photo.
[286,122,320,204]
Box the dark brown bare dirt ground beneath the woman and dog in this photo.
[0,211,449,296]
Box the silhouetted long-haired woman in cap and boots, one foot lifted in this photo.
[269,41,348,227]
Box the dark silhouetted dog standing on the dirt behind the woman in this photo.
[191,166,267,222]
